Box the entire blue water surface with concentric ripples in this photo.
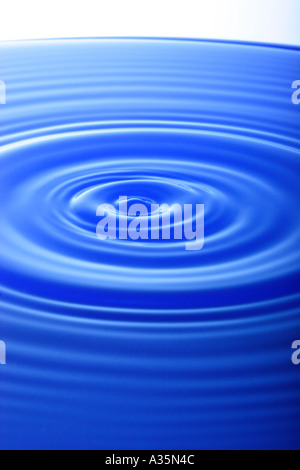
[0,40,300,449]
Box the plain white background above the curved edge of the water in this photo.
[0,0,300,45]
